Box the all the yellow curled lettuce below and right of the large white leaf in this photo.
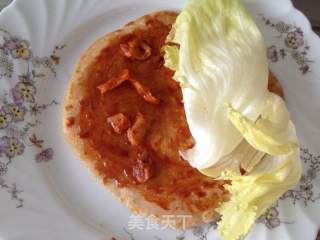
[201,93,301,240]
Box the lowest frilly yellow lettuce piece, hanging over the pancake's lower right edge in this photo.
[218,149,301,240]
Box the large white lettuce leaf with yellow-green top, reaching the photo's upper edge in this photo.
[165,0,268,169]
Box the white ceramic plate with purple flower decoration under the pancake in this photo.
[0,0,320,240]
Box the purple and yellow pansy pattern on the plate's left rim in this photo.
[0,29,65,208]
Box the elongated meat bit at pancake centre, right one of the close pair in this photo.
[127,112,147,146]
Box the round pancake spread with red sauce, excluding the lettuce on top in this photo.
[63,11,282,228]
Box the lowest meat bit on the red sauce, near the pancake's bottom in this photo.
[132,150,155,183]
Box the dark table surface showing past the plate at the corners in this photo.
[0,0,320,240]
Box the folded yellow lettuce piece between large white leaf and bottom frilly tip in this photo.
[200,92,298,177]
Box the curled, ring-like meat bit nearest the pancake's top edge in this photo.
[120,39,152,61]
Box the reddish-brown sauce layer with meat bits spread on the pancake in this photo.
[70,16,280,213]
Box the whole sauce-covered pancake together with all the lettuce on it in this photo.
[63,0,301,239]
